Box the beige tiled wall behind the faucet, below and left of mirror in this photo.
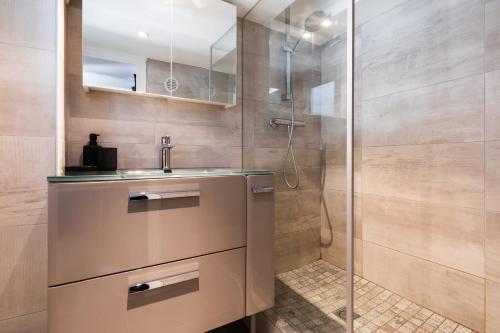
[66,2,242,169]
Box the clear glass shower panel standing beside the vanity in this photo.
[241,0,350,332]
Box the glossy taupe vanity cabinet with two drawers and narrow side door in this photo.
[48,175,274,333]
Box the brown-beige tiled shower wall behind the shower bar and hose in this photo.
[242,21,321,272]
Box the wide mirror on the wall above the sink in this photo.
[82,0,237,105]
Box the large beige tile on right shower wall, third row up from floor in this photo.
[362,142,484,209]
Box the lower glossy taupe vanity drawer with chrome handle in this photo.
[48,248,245,333]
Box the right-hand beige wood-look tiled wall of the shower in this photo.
[321,0,500,332]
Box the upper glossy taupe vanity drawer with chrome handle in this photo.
[49,176,246,286]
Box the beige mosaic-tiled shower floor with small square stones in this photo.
[265,260,475,333]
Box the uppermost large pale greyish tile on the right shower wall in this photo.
[362,0,484,100]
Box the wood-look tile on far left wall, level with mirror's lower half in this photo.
[0,43,56,136]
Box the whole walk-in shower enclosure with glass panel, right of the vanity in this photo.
[239,0,500,333]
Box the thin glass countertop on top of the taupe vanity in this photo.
[47,168,273,183]
